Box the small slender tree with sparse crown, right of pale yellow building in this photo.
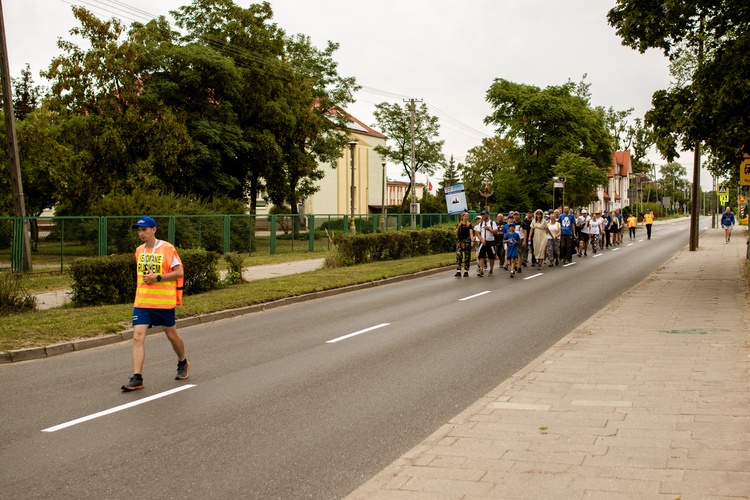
[373,102,445,211]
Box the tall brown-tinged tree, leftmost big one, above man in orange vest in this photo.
[43,7,189,213]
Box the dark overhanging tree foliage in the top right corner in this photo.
[607,0,750,180]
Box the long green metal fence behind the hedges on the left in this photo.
[0,214,457,273]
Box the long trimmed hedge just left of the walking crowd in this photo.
[334,227,456,264]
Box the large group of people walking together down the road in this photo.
[455,206,653,278]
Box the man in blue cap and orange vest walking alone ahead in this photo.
[122,217,190,392]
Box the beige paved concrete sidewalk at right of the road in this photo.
[349,228,750,500]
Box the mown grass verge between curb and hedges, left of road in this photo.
[0,253,455,351]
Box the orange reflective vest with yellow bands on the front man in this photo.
[134,240,184,309]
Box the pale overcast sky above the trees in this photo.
[2,0,711,189]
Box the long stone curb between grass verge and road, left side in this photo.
[0,264,454,365]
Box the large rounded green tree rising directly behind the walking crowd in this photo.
[485,79,613,207]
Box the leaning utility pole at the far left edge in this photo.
[0,0,31,273]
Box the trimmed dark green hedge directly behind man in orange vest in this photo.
[70,249,220,307]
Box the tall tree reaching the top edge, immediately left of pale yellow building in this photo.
[173,0,357,213]
